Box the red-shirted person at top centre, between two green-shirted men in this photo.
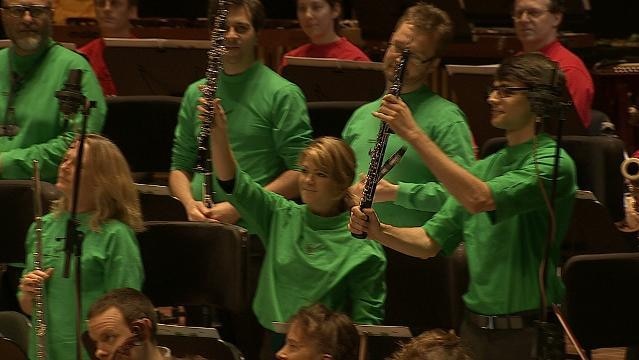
[278,0,370,73]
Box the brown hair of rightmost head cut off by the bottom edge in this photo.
[389,329,472,360]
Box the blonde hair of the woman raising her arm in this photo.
[299,136,356,211]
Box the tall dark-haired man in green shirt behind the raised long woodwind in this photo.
[169,0,311,226]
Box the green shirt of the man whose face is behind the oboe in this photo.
[342,86,475,227]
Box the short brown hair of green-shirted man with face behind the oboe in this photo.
[395,2,454,57]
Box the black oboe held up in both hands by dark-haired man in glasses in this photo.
[351,49,410,239]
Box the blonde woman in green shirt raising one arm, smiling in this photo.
[200,100,386,330]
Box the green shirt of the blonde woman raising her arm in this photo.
[222,171,386,330]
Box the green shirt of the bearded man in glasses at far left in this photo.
[0,41,106,183]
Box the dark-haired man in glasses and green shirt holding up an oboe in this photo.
[349,53,576,359]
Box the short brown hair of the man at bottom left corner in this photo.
[87,288,158,343]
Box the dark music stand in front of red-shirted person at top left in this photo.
[104,38,211,96]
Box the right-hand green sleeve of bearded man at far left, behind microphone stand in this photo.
[0,63,106,180]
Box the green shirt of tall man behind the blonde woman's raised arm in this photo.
[171,62,311,225]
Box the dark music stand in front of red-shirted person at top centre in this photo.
[282,56,386,101]
